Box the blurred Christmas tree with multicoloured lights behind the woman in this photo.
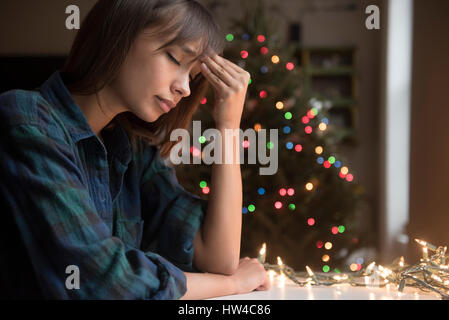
[176,1,372,272]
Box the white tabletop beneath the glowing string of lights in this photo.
[211,276,441,300]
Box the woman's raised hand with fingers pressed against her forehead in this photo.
[200,53,251,128]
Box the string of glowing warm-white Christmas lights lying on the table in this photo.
[258,239,449,300]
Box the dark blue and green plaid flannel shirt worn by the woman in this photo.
[0,72,207,299]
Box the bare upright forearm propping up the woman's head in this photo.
[196,126,242,274]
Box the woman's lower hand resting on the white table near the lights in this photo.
[230,257,270,294]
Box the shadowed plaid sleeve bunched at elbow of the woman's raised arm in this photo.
[141,142,208,272]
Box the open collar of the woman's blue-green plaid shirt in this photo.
[40,71,131,164]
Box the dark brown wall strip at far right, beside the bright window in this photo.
[408,0,449,259]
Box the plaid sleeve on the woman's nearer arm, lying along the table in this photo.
[0,124,186,299]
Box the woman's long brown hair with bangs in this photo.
[61,0,225,157]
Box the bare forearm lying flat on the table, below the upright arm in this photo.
[180,272,236,300]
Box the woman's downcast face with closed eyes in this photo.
[111,32,205,122]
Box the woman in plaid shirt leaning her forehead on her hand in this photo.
[0,0,268,299]
